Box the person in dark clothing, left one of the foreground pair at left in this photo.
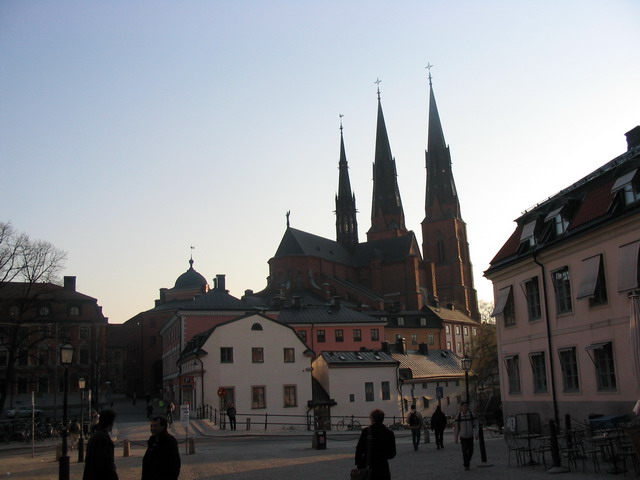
[82,410,118,480]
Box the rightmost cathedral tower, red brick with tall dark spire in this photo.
[422,72,480,320]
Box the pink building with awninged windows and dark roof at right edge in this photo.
[485,127,640,422]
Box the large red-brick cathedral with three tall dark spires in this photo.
[248,75,480,328]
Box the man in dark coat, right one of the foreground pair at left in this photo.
[142,417,181,480]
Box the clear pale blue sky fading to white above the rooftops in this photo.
[0,0,640,323]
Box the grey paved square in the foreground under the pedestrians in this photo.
[0,398,615,480]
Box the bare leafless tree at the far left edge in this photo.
[0,222,66,411]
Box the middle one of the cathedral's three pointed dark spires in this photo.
[367,80,407,244]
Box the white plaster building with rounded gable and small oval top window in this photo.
[179,314,312,428]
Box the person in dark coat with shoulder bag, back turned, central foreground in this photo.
[355,409,396,480]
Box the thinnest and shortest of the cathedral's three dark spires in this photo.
[335,115,358,251]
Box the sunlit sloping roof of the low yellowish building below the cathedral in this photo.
[391,350,464,379]
